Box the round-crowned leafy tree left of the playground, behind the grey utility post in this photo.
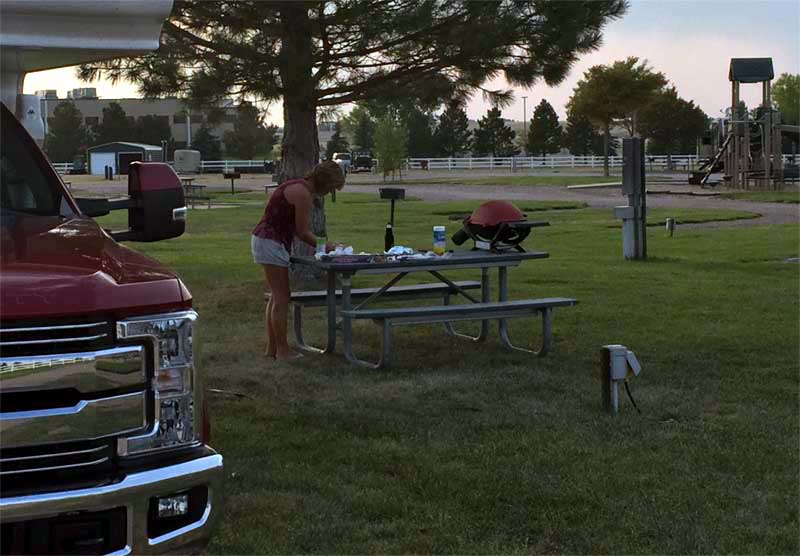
[567,57,667,176]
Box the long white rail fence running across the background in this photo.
[53,154,792,174]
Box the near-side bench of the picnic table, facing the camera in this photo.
[342,297,577,368]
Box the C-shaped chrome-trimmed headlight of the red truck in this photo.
[117,311,199,456]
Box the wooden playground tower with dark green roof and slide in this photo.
[689,58,798,190]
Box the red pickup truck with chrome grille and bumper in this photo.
[0,96,223,554]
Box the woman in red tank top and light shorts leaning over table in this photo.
[251,160,344,360]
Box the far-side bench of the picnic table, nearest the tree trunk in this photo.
[264,280,481,353]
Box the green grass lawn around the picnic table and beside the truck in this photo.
[103,193,800,554]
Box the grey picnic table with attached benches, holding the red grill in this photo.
[291,250,576,368]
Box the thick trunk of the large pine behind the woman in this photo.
[278,2,326,287]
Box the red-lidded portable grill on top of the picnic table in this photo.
[451,201,550,253]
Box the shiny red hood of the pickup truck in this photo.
[0,211,191,320]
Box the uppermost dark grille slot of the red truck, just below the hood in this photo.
[0,319,114,357]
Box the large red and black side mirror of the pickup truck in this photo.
[122,162,186,241]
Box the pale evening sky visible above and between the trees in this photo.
[24,0,800,126]
